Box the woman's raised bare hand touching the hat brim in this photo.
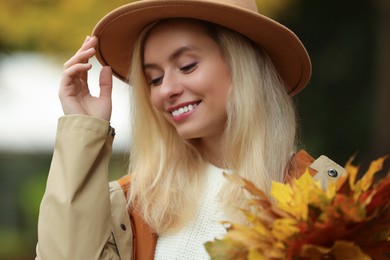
[59,36,112,121]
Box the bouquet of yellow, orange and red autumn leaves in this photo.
[205,158,390,260]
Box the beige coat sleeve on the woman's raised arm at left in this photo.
[36,115,120,260]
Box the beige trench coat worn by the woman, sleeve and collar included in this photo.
[36,115,343,260]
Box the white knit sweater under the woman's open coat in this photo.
[154,165,227,260]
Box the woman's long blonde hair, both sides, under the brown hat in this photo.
[129,19,296,233]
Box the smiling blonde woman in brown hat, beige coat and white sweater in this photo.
[37,0,342,259]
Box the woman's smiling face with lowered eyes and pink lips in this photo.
[144,21,231,139]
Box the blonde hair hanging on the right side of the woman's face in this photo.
[219,28,297,220]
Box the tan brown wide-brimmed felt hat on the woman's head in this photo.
[93,0,311,95]
